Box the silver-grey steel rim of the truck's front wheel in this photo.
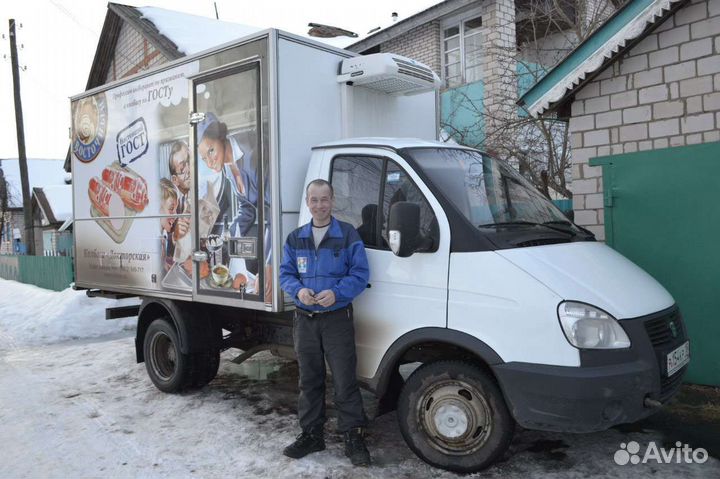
[418,380,492,456]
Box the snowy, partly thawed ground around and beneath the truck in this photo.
[0,281,720,479]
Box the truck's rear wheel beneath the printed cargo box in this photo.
[143,318,193,393]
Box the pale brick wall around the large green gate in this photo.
[570,0,720,240]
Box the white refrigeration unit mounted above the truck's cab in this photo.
[337,53,441,95]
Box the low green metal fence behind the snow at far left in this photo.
[0,255,75,291]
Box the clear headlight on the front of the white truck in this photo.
[558,301,630,349]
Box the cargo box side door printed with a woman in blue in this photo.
[187,60,271,308]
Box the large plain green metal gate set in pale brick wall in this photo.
[590,143,720,385]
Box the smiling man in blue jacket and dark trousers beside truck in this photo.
[280,179,370,466]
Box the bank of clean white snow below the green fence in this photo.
[0,279,138,350]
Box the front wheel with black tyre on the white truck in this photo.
[398,361,515,473]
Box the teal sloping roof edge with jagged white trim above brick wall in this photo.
[518,0,685,117]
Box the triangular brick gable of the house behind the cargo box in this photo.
[105,23,167,83]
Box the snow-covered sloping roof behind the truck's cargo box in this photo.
[137,7,263,55]
